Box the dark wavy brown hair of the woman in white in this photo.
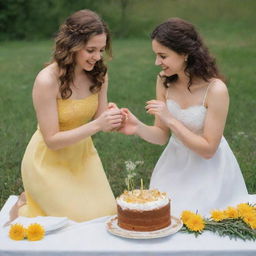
[151,18,223,89]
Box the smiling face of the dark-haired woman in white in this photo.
[152,39,186,76]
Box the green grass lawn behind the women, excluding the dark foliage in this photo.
[0,0,256,207]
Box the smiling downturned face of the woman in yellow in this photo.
[76,34,107,71]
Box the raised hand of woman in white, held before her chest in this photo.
[145,100,173,127]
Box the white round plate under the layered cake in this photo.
[106,215,183,239]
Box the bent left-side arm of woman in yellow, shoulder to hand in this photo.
[33,69,122,150]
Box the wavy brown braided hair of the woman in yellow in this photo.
[52,10,111,99]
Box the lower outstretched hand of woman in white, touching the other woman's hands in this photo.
[118,108,140,135]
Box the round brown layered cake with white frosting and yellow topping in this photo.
[117,189,171,231]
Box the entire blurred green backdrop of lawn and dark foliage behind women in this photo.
[0,0,256,206]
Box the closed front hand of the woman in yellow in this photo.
[95,108,123,132]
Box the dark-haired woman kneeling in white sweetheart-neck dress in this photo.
[120,18,249,216]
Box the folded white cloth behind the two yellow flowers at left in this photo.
[11,216,69,232]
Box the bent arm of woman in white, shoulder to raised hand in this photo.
[149,80,229,159]
